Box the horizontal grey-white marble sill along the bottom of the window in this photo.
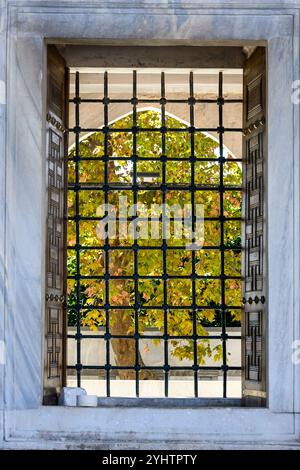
[5,407,300,450]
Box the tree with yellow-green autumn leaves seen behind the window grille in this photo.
[68,111,241,379]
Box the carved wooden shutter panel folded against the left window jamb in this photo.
[44,46,66,405]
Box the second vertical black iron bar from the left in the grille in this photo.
[103,72,111,397]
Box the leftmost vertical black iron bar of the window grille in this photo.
[75,72,81,387]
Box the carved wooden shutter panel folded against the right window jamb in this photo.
[242,47,267,405]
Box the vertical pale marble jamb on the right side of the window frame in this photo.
[266,38,299,412]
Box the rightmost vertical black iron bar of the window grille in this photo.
[218,72,227,398]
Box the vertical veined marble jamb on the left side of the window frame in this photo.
[6,34,46,407]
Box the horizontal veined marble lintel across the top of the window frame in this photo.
[11,6,293,45]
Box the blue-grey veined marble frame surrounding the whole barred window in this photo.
[0,0,300,448]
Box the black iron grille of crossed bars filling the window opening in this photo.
[67,71,243,398]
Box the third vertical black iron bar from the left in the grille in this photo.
[132,70,140,397]
